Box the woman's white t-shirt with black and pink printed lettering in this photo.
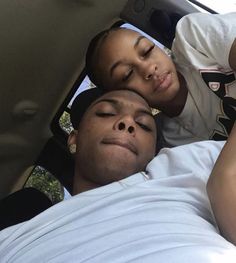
[162,13,236,146]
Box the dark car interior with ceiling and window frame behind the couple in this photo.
[0,0,223,227]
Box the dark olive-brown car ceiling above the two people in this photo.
[0,0,199,198]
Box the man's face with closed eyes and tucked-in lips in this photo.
[75,90,156,185]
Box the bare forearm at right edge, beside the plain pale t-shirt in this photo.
[207,124,236,245]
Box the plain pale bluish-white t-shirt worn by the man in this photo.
[0,141,236,263]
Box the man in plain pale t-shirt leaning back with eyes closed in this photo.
[0,88,236,263]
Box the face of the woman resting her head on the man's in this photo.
[95,29,179,108]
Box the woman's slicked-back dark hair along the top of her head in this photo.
[85,27,122,87]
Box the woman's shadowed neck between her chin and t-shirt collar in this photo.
[160,73,188,118]
